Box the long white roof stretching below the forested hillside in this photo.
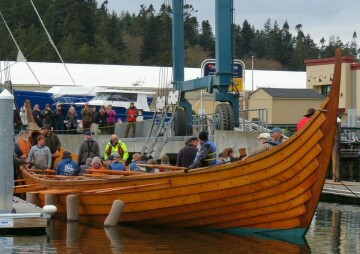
[0,62,306,90]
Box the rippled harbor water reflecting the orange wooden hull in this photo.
[0,202,360,254]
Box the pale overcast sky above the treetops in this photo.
[104,0,360,44]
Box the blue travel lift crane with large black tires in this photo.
[172,0,239,136]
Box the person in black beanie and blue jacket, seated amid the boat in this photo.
[184,131,216,173]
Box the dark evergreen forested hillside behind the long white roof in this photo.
[0,0,359,70]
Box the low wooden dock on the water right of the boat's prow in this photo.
[321,180,360,205]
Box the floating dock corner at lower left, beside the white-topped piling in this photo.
[0,197,51,233]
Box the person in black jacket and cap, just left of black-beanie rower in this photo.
[176,136,199,168]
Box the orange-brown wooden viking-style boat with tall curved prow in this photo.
[18,50,342,237]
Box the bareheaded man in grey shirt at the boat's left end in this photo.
[27,135,51,169]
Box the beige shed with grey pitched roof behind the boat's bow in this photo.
[249,88,324,125]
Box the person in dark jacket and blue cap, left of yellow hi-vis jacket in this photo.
[77,131,100,166]
